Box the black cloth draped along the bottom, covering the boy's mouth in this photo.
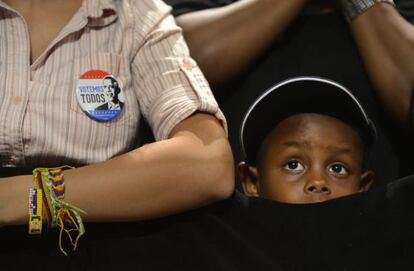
[0,177,414,271]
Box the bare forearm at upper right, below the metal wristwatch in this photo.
[351,3,414,126]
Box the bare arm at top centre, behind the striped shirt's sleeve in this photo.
[176,0,307,84]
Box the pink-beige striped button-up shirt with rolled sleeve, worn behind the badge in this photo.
[0,0,225,167]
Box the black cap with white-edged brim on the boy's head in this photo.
[240,77,376,165]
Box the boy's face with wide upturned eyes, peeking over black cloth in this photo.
[239,113,373,203]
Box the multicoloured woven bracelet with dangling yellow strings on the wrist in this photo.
[29,166,86,256]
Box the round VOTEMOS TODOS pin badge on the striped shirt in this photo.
[76,70,124,121]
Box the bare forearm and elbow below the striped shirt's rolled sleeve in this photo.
[0,113,234,225]
